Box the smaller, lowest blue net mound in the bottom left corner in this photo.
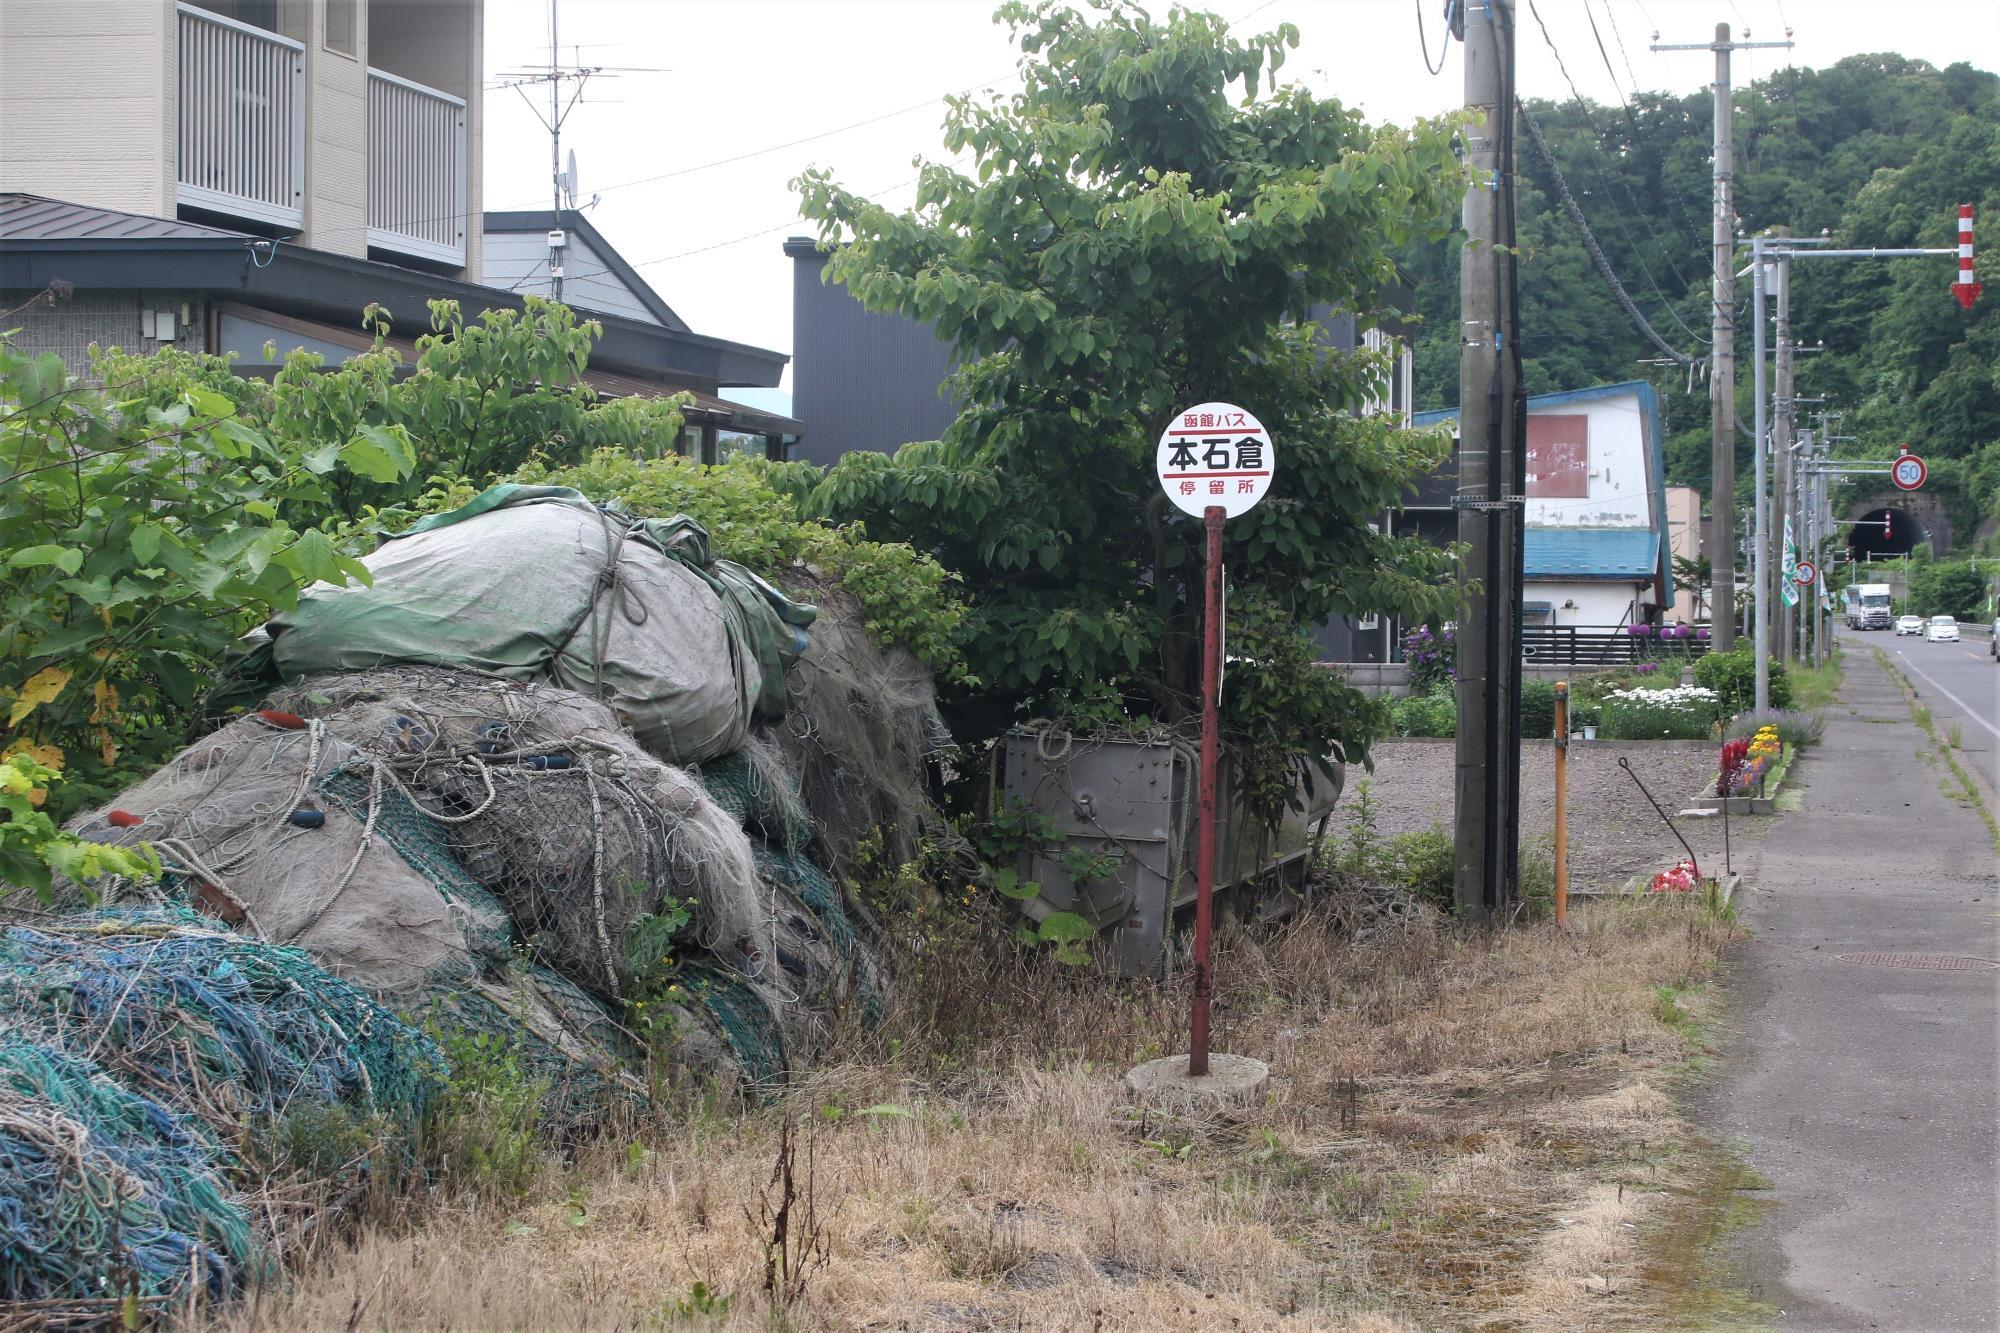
[0,1033,264,1304]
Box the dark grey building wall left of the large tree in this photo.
[786,240,958,464]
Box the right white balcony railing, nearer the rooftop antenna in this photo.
[368,70,466,266]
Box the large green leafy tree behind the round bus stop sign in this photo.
[798,0,1464,817]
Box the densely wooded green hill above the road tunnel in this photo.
[1404,54,2000,546]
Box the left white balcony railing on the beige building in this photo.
[178,4,306,228]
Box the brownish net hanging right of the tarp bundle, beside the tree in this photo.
[776,574,952,873]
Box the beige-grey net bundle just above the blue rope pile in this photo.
[52,715,510,997]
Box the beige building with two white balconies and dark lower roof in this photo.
[0,0,800,452]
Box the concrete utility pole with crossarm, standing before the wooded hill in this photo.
[1652,24,1792,652]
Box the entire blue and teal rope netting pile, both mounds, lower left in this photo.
[0,909,444,1301]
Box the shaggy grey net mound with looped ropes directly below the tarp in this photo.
[270,667,770,997]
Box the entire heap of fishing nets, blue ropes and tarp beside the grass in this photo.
[0,486,944,1299]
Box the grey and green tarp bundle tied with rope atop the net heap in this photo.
[254,484,816,765]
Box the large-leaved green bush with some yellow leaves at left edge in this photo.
[0,340,416,815]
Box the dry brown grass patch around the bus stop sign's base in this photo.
[207,903,1730,1331]
